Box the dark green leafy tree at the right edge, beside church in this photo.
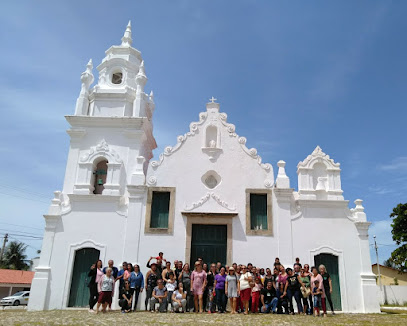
[390,203,407,273]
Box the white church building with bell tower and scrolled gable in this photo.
[28,23,380,313]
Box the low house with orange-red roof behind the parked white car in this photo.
[0,269,34,298]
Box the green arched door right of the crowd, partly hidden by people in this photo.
[314,254,342,310]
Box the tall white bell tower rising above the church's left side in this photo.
[62,22,157,196]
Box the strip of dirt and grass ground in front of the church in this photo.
[0,310,407,326]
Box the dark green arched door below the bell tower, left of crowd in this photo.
[68,248,100,307]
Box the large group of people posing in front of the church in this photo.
[89,252,334,316]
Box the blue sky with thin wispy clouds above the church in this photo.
[0,0,407,262]
